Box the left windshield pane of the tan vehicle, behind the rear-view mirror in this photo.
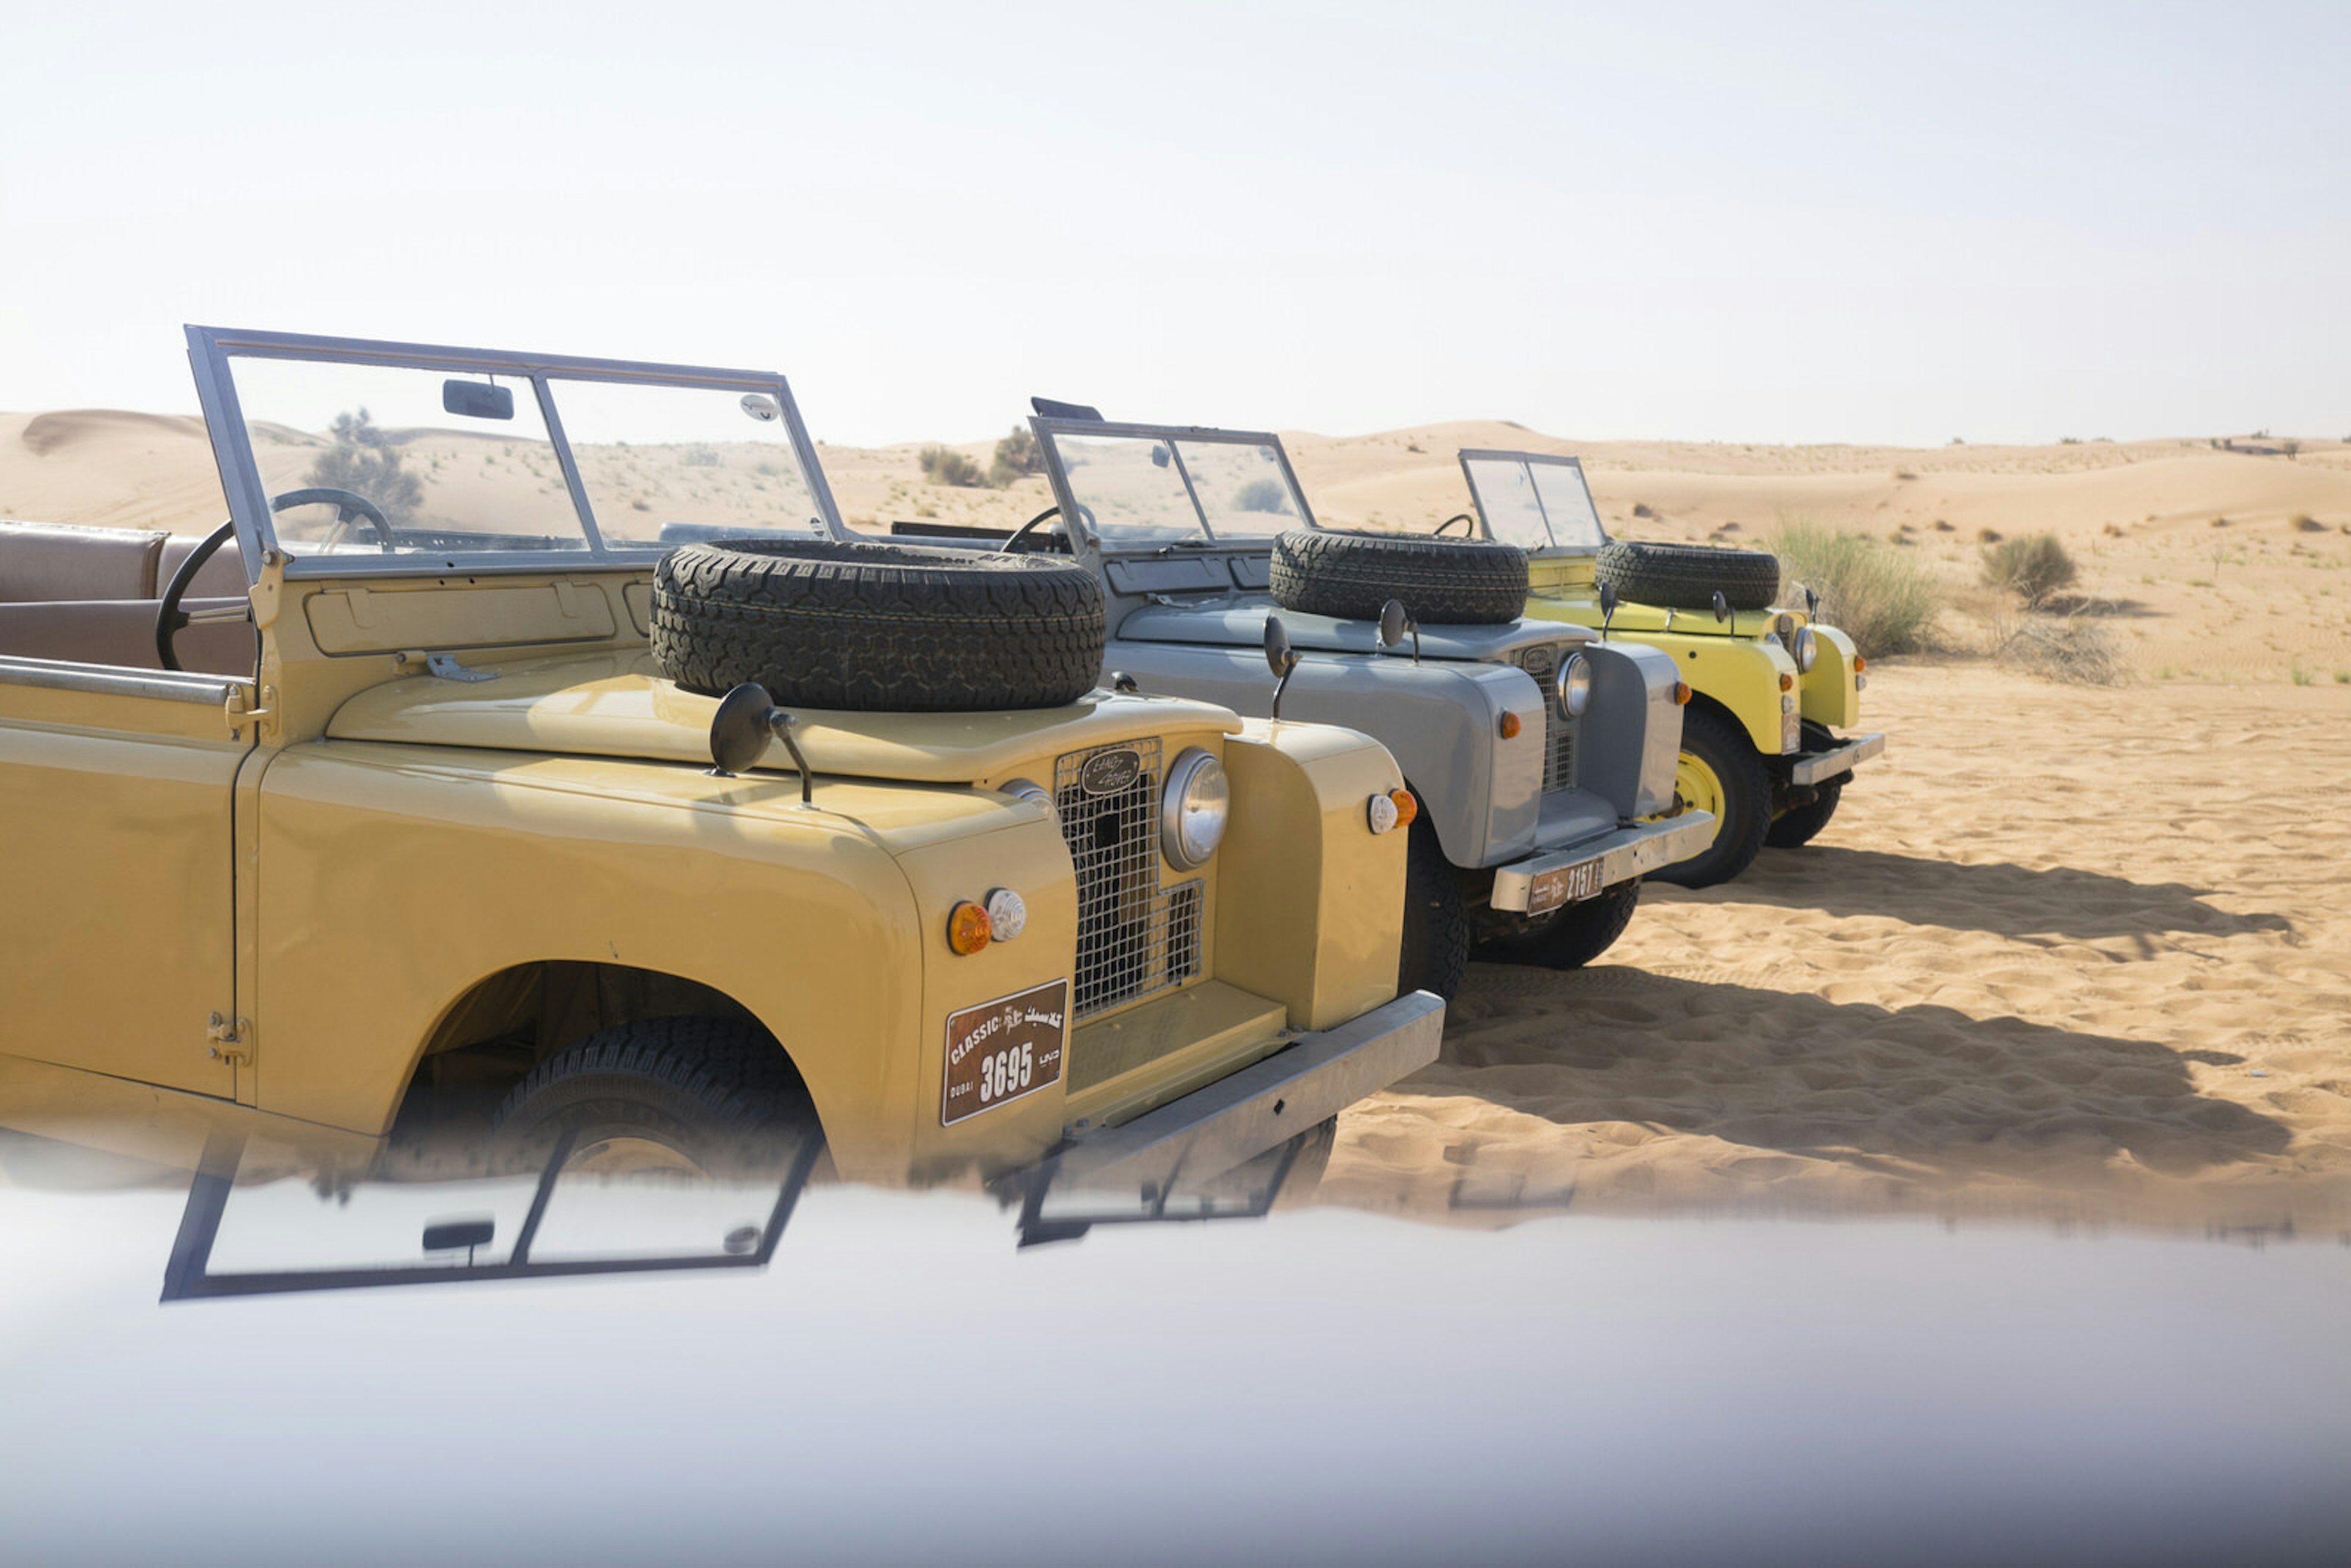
[230,355,588,555]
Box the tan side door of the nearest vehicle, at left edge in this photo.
[0,672,252,1098]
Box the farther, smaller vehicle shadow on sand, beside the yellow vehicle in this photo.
[1674,846,2295,940]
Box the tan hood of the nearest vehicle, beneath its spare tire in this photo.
[327,651,1242,783]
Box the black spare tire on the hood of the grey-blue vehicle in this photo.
[1272,529,1526,625]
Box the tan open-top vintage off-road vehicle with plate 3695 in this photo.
[0,327,1444,1192]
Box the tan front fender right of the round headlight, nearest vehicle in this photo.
[1215,719,1406,1030]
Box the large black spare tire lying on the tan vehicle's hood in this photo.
[654,538,1105,712]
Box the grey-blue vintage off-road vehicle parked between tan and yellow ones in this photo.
[896,400,1712,994]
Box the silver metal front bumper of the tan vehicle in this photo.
[1049,992,1446,1201]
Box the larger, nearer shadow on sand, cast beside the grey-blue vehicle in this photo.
[1399,964,2292,1182]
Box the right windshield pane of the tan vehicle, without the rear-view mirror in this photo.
[548,376,825,546]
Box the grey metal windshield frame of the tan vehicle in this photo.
[186,327,849,580]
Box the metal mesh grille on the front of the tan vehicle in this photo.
[1053,738,1201,1018]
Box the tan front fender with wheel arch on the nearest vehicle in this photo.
[254,740,940,1150]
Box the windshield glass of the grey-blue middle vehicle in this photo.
[1044,430,1312,548]
